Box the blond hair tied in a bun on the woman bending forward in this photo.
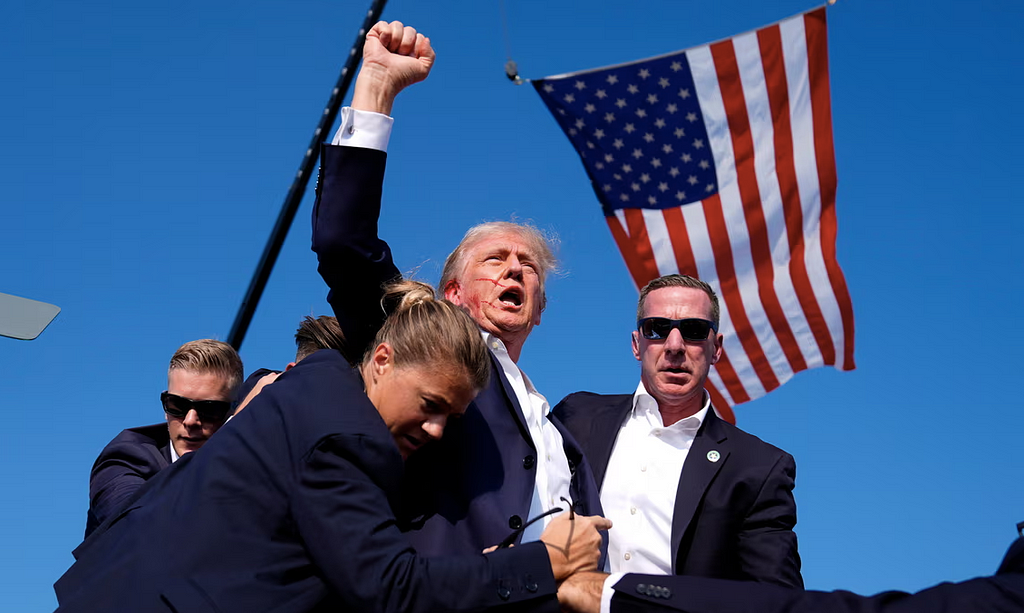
[362,279,490,390]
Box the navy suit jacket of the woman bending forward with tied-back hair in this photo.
[54,350,557,613]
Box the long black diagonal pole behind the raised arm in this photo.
[227,0,387,350]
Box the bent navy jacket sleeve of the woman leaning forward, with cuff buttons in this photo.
[293,436,558,612]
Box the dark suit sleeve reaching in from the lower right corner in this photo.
[611,538,1024,613]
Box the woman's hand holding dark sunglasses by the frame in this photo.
[541,513,611,581]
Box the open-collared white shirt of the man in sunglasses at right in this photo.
[601,383,711,574]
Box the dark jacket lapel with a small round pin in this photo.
[672,408,729,572]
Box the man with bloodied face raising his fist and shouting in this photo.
[312,21,600,555]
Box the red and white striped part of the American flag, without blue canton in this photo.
[606,7,854,418]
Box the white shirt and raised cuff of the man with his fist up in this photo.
[331,106,572,542]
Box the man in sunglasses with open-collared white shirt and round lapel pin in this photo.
[554,274,803,587]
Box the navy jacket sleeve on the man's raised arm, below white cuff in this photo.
[312,144,401,363]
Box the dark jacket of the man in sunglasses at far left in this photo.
[85,423,171,538]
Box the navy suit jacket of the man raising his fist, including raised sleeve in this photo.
[312,145,601,555]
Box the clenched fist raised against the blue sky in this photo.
[351,21,435,115]
